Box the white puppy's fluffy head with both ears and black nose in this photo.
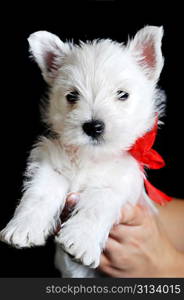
[28,26,163,154]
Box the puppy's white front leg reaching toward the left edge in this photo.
[0,161,68,248]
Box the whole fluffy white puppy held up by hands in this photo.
[1,26,163,277]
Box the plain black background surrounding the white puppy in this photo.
[0,1,184,277]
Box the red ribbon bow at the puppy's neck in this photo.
[129,117,172,205]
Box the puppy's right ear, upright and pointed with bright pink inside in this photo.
[128,26,164,81]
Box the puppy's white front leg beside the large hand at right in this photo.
[56,189,123,268]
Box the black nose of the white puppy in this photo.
[82,120,105,138]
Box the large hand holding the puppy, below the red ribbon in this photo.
[99,204,184,278]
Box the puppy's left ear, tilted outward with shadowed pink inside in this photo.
[28,31,69,84]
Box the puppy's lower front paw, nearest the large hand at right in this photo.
[55,222,101,268]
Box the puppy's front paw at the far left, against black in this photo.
[0,220,47,248]
